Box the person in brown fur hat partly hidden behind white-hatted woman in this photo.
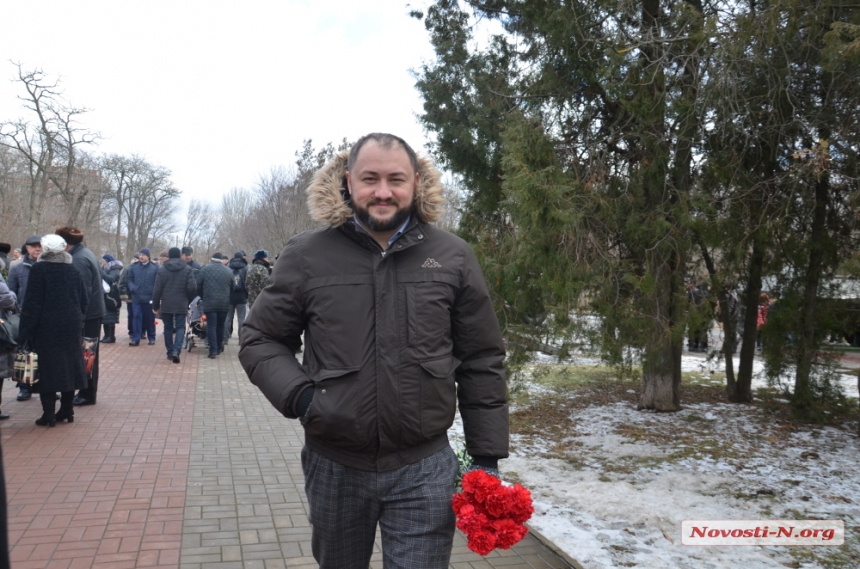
[56,227,105,405]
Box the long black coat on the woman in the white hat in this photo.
[18,252,90,392]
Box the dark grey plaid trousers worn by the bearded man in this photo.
[302,447,459,569]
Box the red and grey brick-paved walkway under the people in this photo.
[0,325,569,569]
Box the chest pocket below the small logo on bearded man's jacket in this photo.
[399,273,459,356]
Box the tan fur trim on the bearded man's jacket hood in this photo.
[307,150,445,227]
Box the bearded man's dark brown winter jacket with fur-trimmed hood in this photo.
[239,149,508,471]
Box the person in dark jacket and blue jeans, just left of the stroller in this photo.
[152,247,197,364]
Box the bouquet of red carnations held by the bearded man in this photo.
[451,470,535,555]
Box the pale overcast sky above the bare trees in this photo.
[0,0,433,209]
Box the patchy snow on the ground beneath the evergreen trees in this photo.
[449,354,860,569]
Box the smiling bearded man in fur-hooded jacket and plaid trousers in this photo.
[239,133,508,569]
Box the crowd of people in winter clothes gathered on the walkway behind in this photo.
[0,231,272,427]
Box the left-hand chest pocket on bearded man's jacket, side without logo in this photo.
[305,275,375,369]
